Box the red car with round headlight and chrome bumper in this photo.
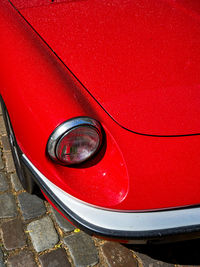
[0,0,200,242]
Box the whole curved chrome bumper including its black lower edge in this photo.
[21,154,200,243]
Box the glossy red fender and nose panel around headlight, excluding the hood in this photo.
[0,0,200,210]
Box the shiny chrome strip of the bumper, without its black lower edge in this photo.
[22,154,200,232]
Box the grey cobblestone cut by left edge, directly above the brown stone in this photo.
[0,193,17,218]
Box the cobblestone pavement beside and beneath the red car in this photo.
[0,103,200,267]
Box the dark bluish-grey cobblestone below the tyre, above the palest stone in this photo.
[18,192,46,220]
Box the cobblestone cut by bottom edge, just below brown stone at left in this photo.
[8,251,37,267]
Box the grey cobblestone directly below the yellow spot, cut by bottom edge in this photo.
[64,232,99,267]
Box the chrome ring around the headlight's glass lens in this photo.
[47,117,102,165]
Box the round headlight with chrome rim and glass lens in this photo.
[47,117,102,165]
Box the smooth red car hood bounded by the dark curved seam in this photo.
[12,0,200,135]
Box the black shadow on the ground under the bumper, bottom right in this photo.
[126,239,200,266]
